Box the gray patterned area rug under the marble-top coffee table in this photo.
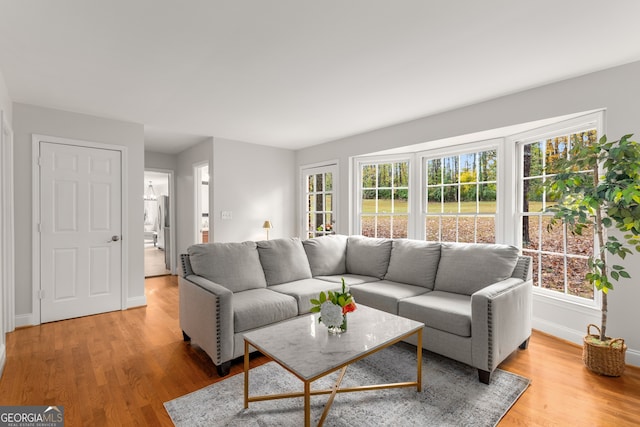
[164,343,529,427]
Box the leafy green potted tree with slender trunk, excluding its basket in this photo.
[546,135,640,341]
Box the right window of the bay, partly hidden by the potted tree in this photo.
[519,129,597,299]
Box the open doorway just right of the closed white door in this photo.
[143,170,172,277]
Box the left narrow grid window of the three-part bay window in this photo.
[359,160,410,238]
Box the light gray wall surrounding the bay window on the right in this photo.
[296,62,640,365]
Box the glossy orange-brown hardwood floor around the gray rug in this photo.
[0,276,640,426]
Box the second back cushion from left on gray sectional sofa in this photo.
[257,237,311,286]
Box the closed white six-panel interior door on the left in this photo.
[39,141,122,322]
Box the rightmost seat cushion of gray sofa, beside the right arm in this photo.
[398,291,471,337]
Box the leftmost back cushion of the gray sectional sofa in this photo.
[187,242,267,292]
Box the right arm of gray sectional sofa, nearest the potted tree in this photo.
[471,277,532,372]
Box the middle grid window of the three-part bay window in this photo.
[423,149,498,243]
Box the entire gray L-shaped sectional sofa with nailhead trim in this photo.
[179,235,532,383]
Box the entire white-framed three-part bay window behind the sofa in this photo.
[352,112,603,306]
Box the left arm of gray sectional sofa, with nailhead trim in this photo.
[178,275,234,365]
